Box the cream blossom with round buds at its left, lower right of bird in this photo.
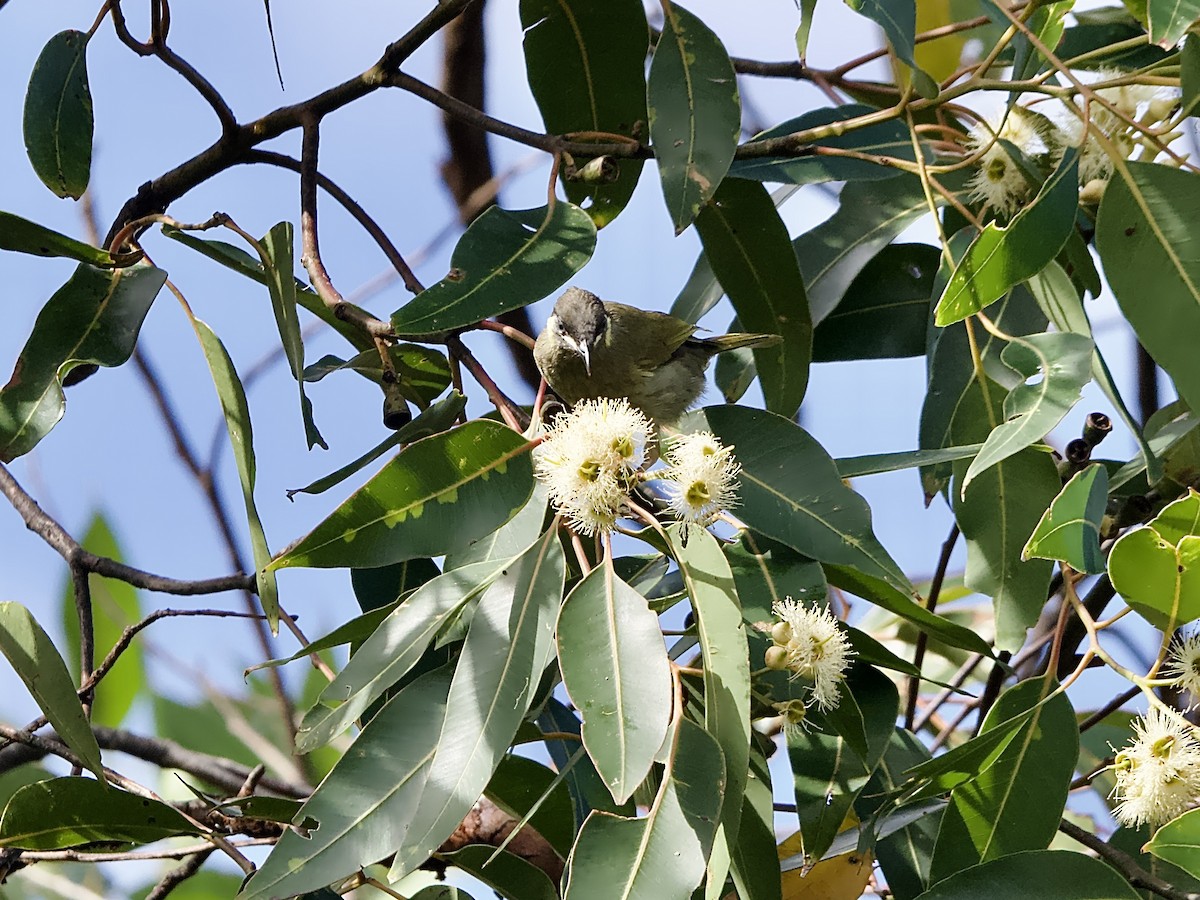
[767,598,853,710]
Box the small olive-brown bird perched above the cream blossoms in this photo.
[533,287,782,426]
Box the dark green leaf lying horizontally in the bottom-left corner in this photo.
[0,778,200,850]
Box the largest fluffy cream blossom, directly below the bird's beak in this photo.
[534,397,650,535]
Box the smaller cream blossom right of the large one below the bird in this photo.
[662,431,742,527]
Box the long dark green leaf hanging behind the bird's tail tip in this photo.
[696,178,812,416]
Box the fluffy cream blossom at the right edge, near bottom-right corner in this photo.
[1112,707,1200,828]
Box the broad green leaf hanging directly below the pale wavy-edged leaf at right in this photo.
[954,448,1062,650]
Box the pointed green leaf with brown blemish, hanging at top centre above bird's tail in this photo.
[647,4,742,234]
